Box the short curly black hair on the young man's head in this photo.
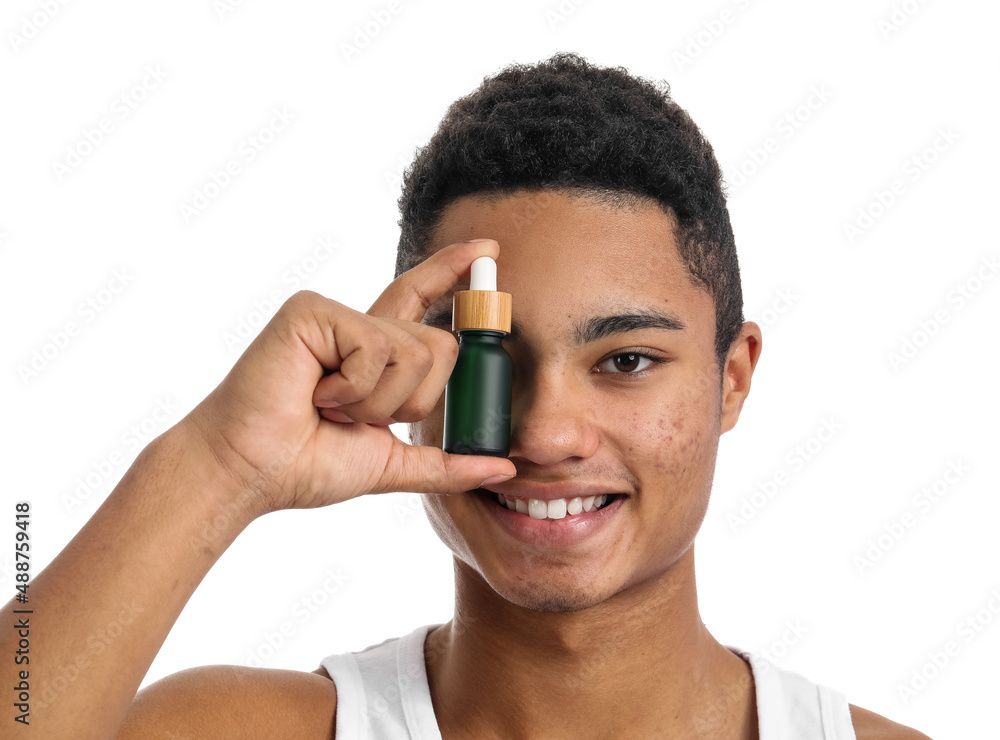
[396,53,743,370]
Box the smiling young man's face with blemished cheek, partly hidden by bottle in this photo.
[411,192,721,611]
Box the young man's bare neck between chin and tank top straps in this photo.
[425,548,757,740]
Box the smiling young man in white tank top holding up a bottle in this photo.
[9,55,924,740]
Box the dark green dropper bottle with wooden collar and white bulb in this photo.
[442,257,513,457]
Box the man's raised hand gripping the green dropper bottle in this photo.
[181,240,515,515]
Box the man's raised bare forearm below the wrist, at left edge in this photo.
[0,423,258,738]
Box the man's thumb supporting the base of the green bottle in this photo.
[381,443,517,493]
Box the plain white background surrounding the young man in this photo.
[0,0,1000,737]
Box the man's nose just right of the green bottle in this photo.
[510,367,600,465]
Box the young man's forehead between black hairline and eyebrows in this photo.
[427,191,714,342]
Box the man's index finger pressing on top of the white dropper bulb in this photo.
[367,239,500,322]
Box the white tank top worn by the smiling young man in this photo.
[322,625,857,740]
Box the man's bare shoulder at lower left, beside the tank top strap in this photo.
[118,666,337,740]
